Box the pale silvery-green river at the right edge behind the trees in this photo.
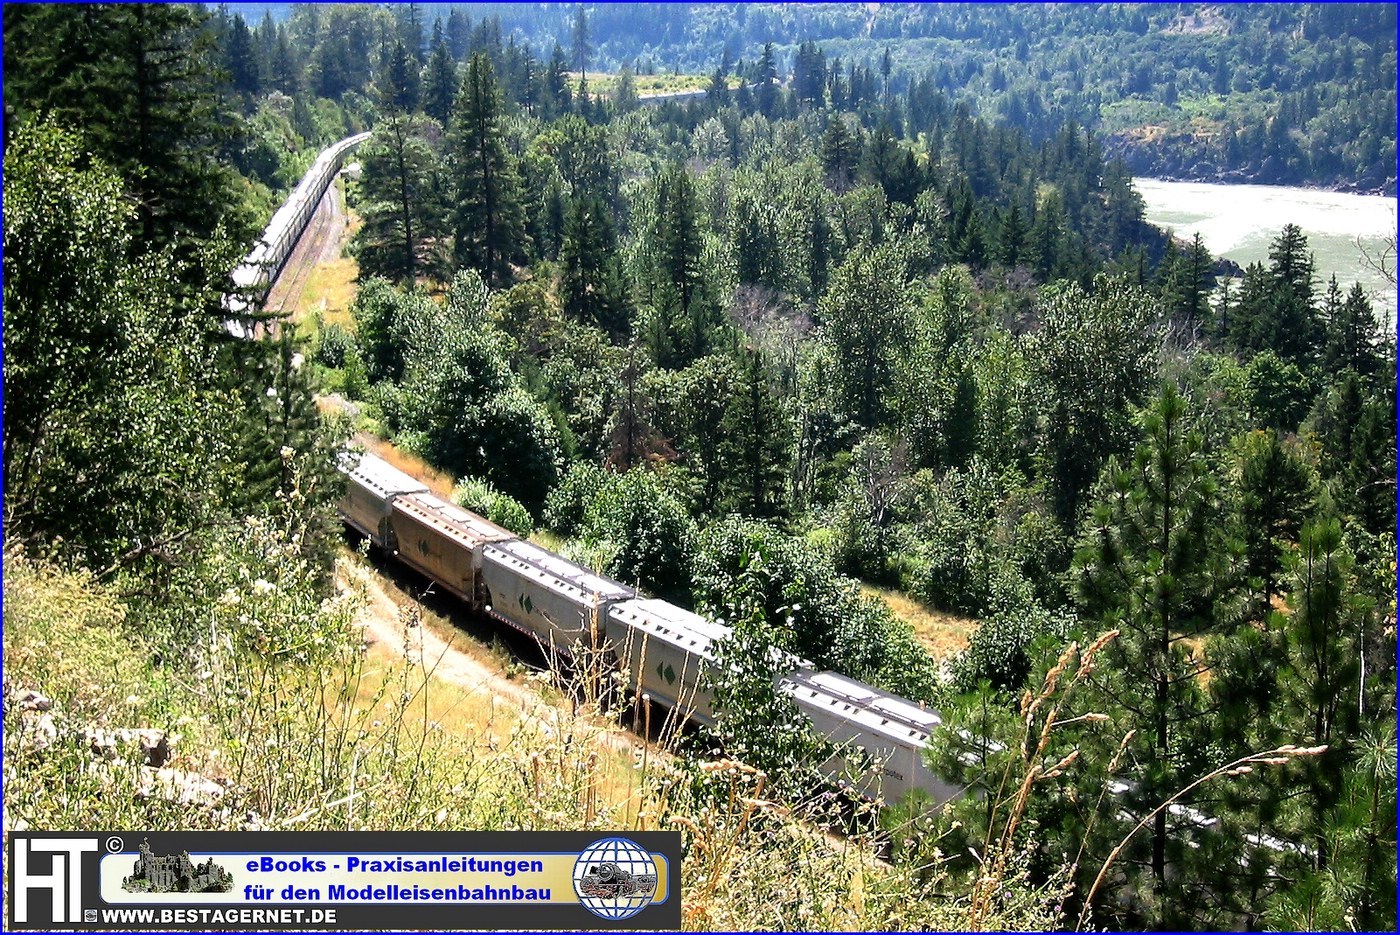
[1133,179,1396,333]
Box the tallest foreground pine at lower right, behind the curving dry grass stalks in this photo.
[1072,385,1219,924]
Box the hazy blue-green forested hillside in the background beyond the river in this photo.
[229,3,1396,195]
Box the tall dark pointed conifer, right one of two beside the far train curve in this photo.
[452,52,528,286]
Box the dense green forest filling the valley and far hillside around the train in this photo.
[4,4,1396,929]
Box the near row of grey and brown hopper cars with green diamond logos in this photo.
[340,454,958,802]
